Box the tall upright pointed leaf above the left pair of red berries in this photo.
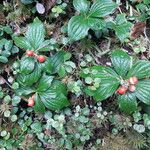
[26,18,45,50]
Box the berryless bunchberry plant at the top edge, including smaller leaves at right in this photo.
[68,0,132,42]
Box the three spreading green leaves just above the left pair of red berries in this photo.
[13,18,51,57]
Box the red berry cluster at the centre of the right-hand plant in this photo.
[117,77,138,95]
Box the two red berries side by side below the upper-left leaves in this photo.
[26,50,46,63]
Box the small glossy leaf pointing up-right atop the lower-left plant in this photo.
[37,74,54,92]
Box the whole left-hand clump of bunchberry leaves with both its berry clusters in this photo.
[14,18,71,112]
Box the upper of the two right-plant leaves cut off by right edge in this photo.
[127,60,150,79]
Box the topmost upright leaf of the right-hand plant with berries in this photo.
[111,50,132,77]
